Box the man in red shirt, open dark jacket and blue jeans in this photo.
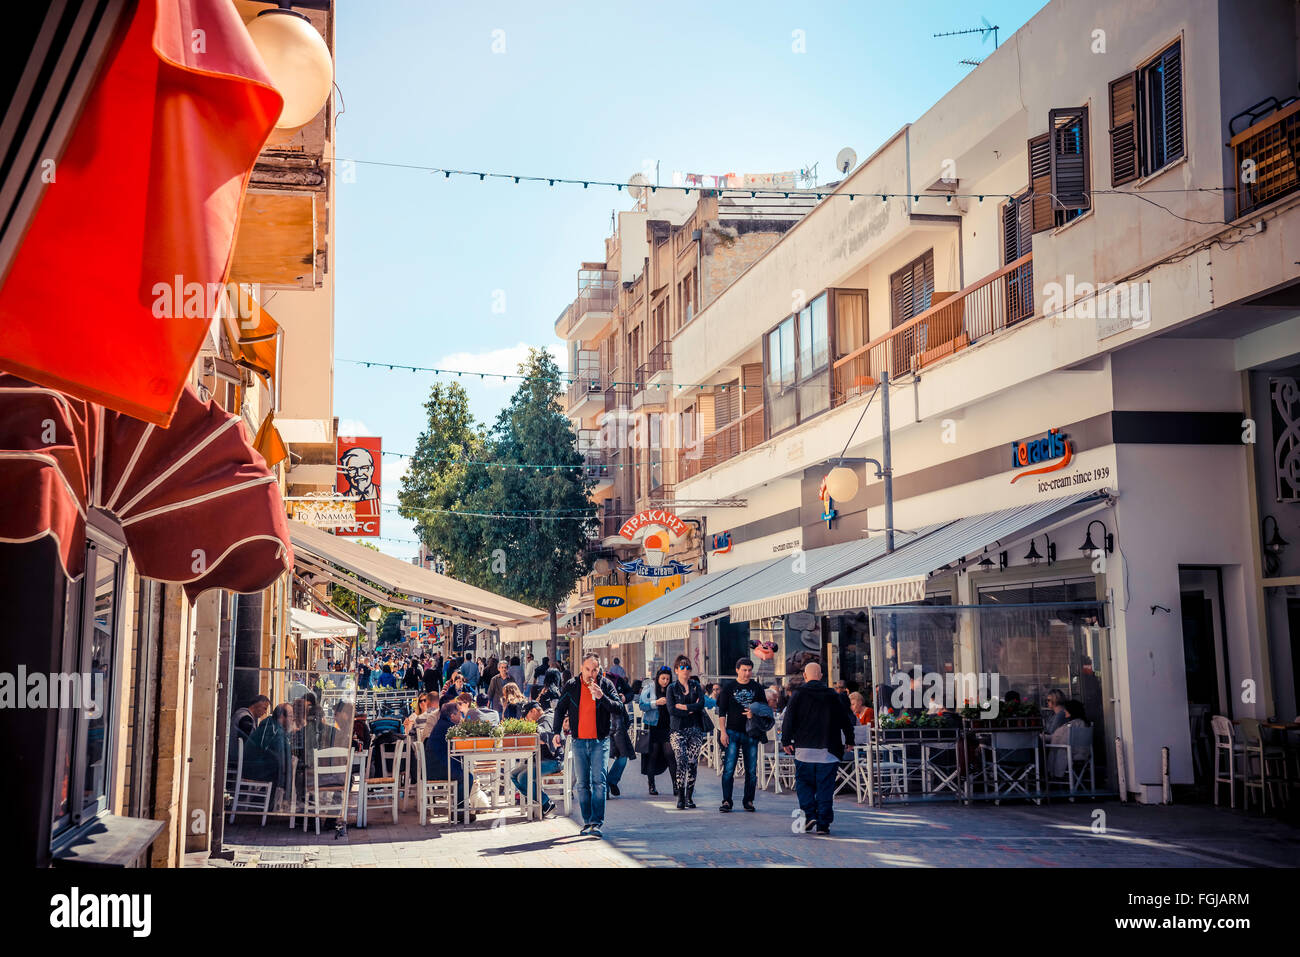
[551,651,623,837]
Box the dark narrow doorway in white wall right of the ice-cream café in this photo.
[1178,566,1232,785]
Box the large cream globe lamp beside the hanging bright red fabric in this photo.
[248,0,334,130]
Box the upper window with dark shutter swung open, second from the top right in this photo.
[1028,107,1092,233]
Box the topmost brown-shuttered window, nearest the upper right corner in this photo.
[1110,42,1183,186]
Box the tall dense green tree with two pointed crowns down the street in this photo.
[398,350,594,659]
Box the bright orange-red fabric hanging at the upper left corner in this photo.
[0,0,282,425]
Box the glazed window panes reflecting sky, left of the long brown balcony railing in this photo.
[764,293,831,434]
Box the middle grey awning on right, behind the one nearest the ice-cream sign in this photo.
[720,525,943,622]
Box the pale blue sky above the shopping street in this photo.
[332,0,1045,558]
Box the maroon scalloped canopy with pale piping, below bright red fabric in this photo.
[0,373,294,601]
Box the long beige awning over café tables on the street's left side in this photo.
[289,521,546,628]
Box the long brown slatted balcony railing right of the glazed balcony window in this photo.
[832,254,1034,406]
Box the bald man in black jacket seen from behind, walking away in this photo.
[781,662,853,833]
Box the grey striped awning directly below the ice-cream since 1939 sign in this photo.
[814,492,1113,614]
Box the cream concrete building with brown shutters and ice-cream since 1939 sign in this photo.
[593,0,1300,801]
